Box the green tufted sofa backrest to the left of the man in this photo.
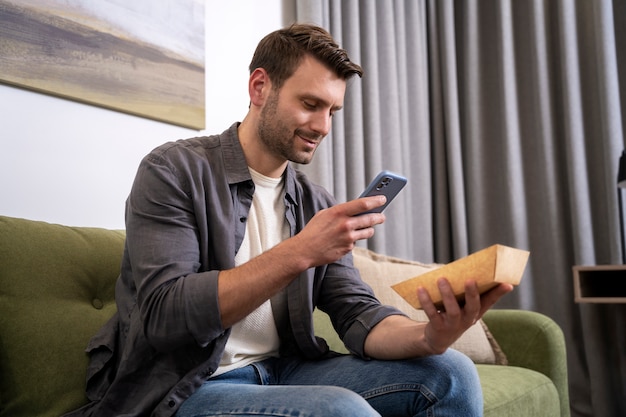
[0,216,124,417]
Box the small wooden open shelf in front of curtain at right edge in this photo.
[573,265,626,304]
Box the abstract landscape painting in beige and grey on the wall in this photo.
[0,0,205,130]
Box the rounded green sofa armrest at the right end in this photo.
[483,309,570,416]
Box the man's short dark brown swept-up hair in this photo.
[250,24,363,88]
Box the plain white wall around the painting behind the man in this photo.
[0,0,290,228]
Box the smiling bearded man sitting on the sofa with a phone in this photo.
[68,25,512,417]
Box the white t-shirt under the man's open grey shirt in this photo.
[213,168,289,377]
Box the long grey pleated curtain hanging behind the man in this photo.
[296,0,626,417]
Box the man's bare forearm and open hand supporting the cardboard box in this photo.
[365,278,513,359]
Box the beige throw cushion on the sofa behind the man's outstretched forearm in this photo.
[353,247,507,365]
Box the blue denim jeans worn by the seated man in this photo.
[176,349,483,417]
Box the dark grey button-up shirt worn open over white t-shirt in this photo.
[71,124,401,417]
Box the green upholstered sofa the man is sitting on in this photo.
[0,216,569,417]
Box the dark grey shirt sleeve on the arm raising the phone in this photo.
[126,145,224,351]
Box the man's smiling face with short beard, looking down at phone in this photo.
[258,57,346,164]
